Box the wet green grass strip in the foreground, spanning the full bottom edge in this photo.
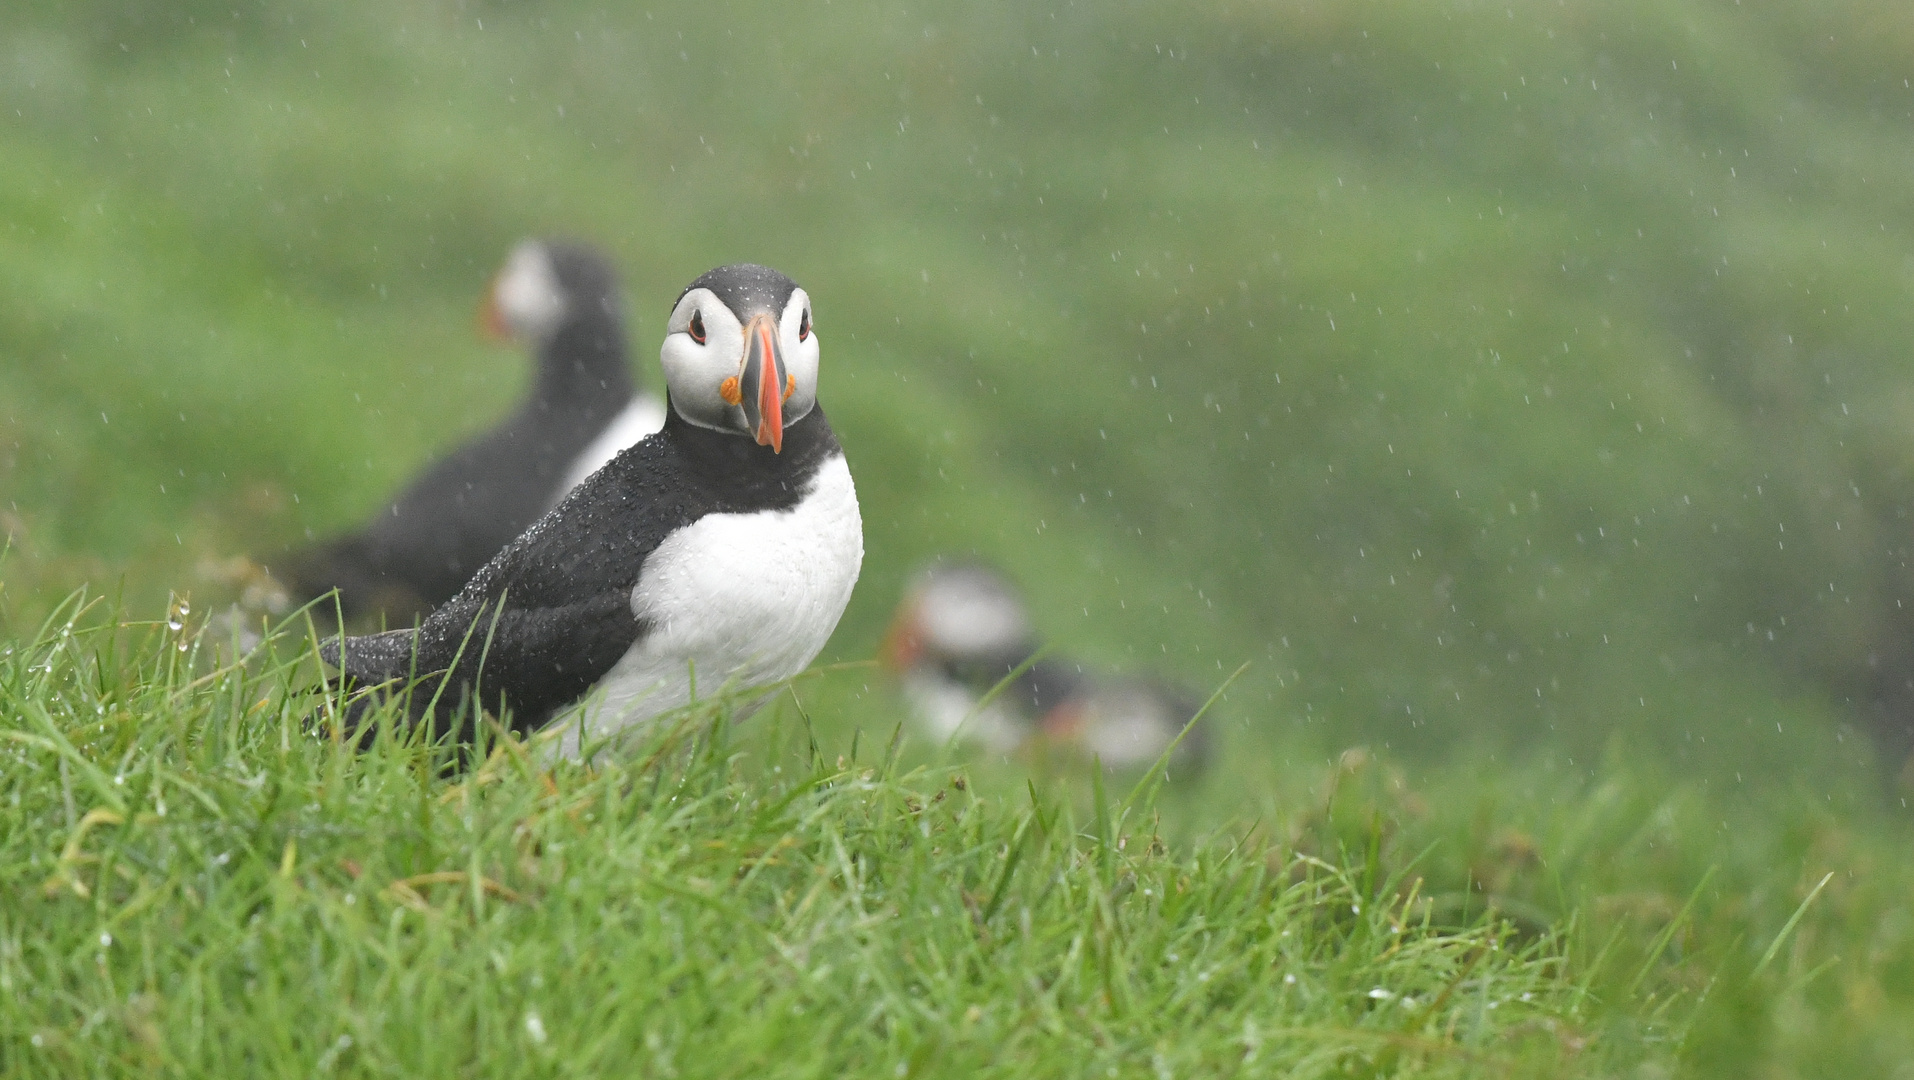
[0,599,1914,1076]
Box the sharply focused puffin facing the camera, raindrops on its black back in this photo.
[320,264,863,758]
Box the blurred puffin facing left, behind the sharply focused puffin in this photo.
[289,239,664,624]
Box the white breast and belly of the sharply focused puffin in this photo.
[563,454,863,754]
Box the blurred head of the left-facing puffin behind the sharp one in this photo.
[479,239,624,347]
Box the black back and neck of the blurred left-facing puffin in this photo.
[289,241,634,620]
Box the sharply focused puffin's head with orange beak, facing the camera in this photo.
[658,262,817,452]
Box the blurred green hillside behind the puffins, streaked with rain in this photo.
[11,0,1914,799]
